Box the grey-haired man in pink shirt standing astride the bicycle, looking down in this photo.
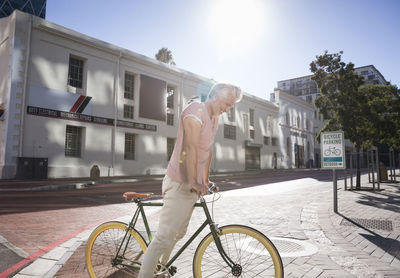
[139,83,242,278]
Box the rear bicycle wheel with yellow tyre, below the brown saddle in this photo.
[86,221,147,278]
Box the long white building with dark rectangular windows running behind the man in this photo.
[0,11,313,179]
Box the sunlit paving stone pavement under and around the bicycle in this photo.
[5,175,400,278]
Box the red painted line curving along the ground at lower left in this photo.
[0,213,126,278]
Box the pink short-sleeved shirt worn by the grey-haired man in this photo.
[166,102,218,184]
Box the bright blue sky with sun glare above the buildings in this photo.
[46,0,400,100]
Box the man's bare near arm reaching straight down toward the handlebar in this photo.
[182,117,207,195]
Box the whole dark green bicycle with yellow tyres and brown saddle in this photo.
[86,184,284,278]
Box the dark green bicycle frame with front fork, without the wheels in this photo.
[113,197,235,269]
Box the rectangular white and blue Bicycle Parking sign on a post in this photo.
[321,131,346,169]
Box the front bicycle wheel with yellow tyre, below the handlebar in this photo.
[193,225,283,278]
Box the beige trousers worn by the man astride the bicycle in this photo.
[138,176,198,278]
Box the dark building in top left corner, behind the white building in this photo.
[0,0,47,18]
